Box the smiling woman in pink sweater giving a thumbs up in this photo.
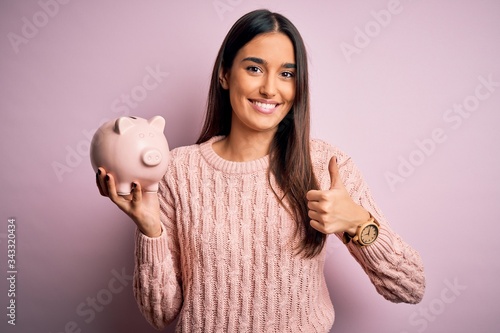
[97,10,425,333]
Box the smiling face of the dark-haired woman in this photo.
[220,33,296,135]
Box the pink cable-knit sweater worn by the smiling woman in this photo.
[134,137,425,333]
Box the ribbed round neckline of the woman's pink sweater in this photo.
[200,136,269,173]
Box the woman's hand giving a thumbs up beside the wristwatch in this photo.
[306,156,370,235]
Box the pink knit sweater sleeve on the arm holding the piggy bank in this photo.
[134,172,183,329]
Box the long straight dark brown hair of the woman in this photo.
[197,10,326,258]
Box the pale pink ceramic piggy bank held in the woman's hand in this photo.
[90,116,170,195]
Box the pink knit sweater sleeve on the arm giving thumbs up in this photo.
[313,141,425,303]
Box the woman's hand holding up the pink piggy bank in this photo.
[96,168,162,237]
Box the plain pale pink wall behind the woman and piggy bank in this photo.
[0,0,500,333]
